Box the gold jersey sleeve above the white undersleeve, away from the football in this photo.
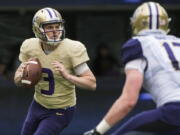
[70,42,89,67]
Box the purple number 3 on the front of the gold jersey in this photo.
[41,68,54,95]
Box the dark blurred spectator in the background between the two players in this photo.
[92,43,120,76]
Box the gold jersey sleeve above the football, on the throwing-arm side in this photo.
[19,40,29,62]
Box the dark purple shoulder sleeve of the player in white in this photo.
[121,39,145,65]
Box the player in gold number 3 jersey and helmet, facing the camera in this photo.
[14,8,96,135]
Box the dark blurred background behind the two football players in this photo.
[0,0,180,135]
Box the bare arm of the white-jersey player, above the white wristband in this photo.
[102,72,143,126]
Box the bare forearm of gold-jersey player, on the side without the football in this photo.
[66,75,96,90]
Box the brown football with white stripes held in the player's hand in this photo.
[21,58,42,88]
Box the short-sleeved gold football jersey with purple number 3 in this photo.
[19,38,89,109]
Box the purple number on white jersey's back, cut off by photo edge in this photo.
[163,42,180,70]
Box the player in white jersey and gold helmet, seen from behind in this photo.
[84,2,180,135]
